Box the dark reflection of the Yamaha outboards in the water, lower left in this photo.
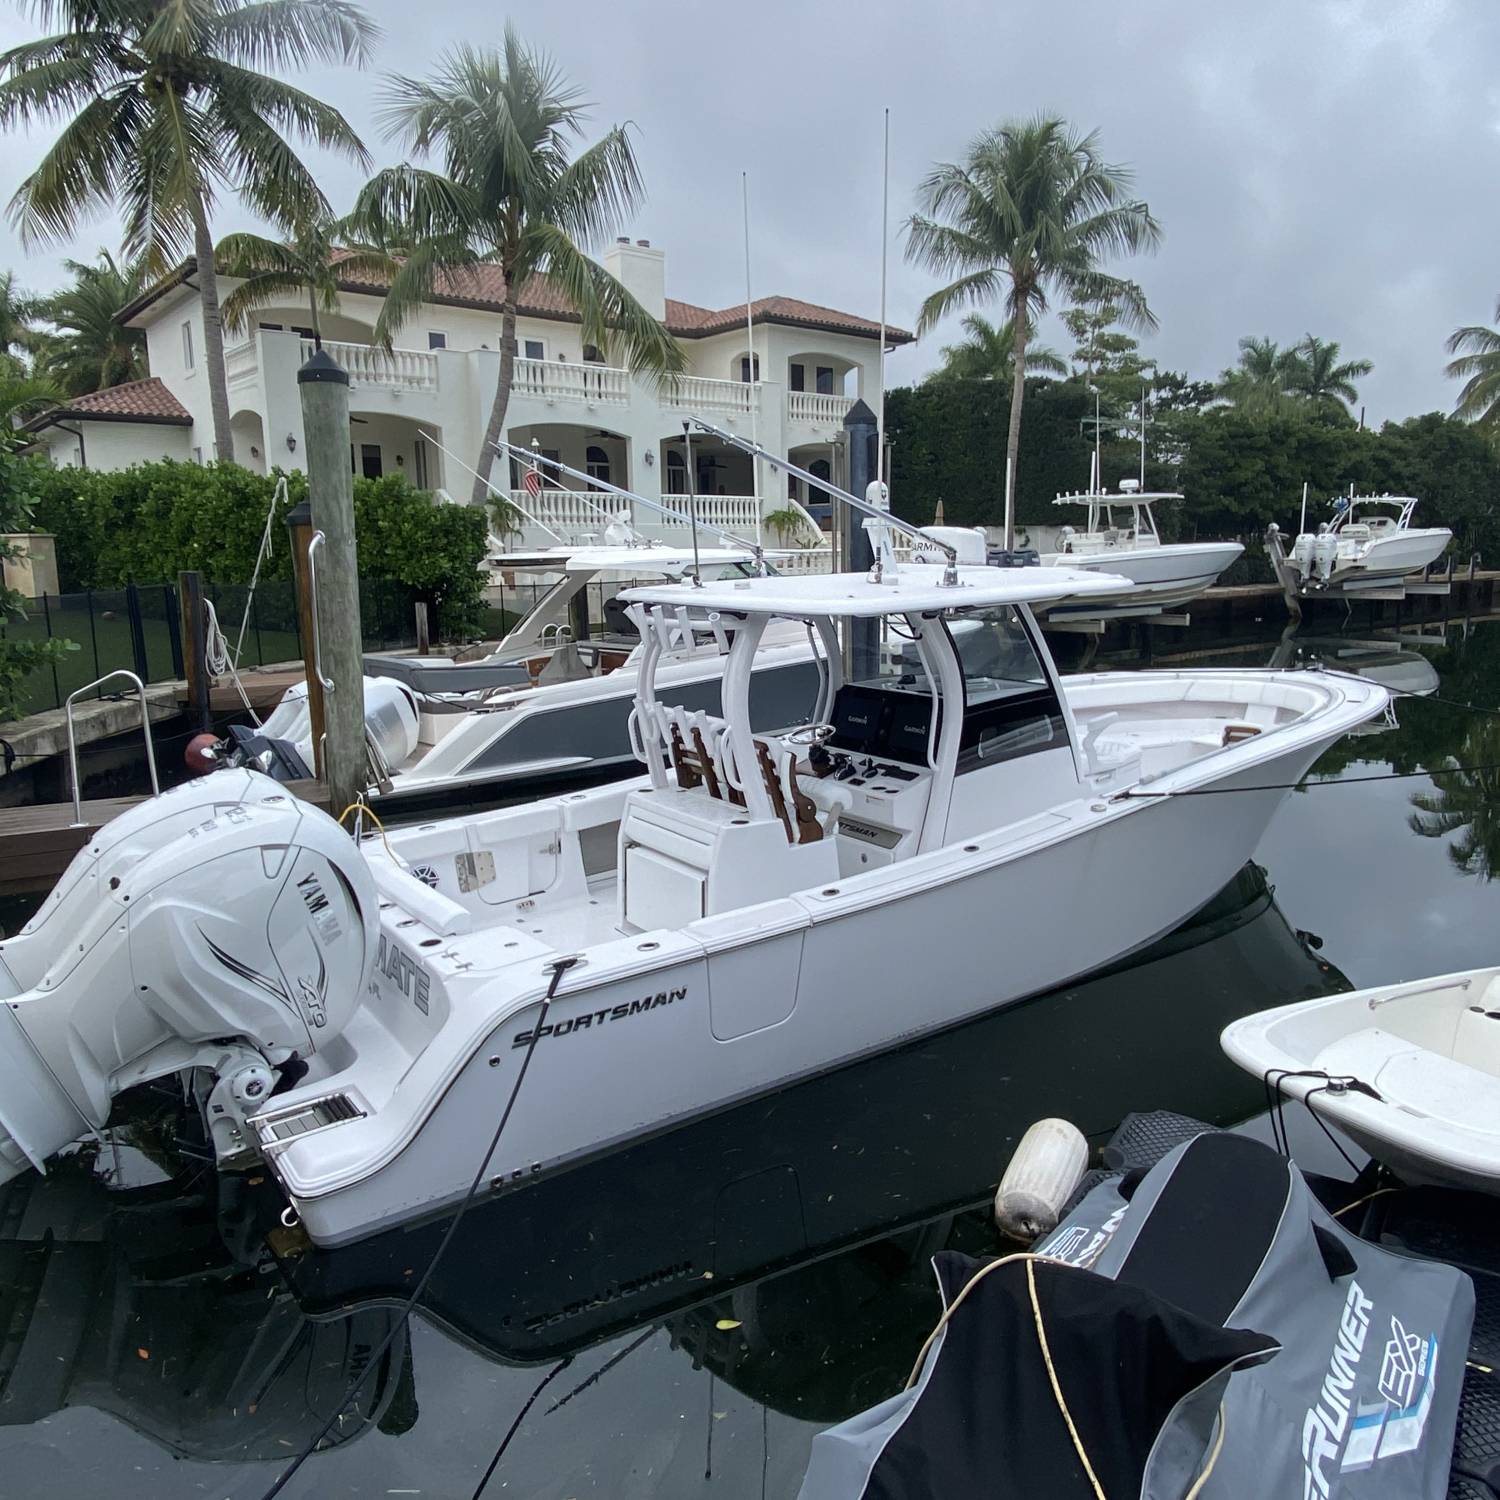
[0,1157,416,1458]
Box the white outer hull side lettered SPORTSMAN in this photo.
[270,674,1385,1245]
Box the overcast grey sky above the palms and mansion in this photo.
[0,0,1500,422]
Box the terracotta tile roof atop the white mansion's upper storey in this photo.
[120,260,912,344]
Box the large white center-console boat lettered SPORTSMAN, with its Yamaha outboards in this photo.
[0,474,1386,1245]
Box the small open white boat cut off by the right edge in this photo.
[1221,969,1500,1194]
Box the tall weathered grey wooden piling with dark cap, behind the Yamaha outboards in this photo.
[297,350,369,816]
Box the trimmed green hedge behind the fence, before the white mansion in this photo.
[30,459,486,638]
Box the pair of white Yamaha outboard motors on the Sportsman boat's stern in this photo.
[0,770,380,1182]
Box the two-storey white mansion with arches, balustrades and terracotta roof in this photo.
[29,240,911,545]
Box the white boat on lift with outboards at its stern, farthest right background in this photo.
[1271,486,1454,594]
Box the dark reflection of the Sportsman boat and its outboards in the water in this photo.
[0,866,1347,1460]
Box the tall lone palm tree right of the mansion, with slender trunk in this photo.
[906,116,1161,548]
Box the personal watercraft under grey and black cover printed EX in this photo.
[801,1133,1475,1500]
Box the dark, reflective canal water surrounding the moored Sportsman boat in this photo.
[0,612,1500,1500]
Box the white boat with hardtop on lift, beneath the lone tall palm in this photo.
[1040,479,1245,621]
